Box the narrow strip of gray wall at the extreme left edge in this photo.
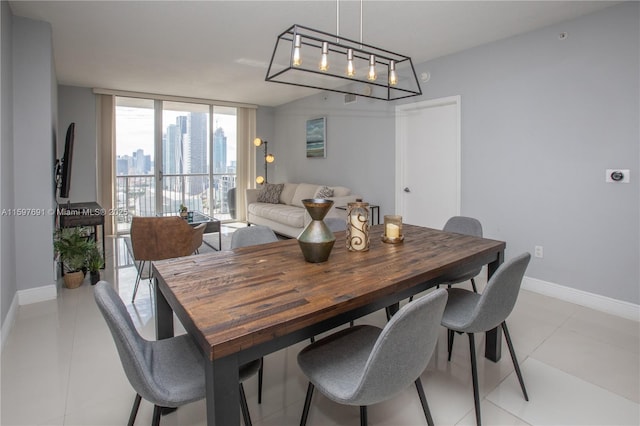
[0,1,17,326]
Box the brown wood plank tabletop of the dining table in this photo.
[153,225,505,360]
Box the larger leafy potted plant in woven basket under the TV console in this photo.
[53,228,95,288]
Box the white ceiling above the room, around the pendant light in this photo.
[9,0,617,106]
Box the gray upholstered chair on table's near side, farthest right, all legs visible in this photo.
[442,253,531,426]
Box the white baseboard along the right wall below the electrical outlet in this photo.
[522,277,640,322]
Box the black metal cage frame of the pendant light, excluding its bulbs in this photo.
[265,24,422,101]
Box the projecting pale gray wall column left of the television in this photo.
[12,17,57,291]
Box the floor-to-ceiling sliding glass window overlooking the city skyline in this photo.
[115,96,238,233]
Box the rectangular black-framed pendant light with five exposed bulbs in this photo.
[265,24,422,101]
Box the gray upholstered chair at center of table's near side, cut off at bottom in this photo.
[298,289,447,425]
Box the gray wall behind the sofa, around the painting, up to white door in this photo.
[269,92,395,214]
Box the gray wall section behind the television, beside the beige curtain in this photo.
[57,86,98,203]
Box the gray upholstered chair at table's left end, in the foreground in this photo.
[94,281,261,426]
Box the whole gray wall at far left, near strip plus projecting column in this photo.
[0,9,58,330]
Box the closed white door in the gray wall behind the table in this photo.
[396,96,460,229]
